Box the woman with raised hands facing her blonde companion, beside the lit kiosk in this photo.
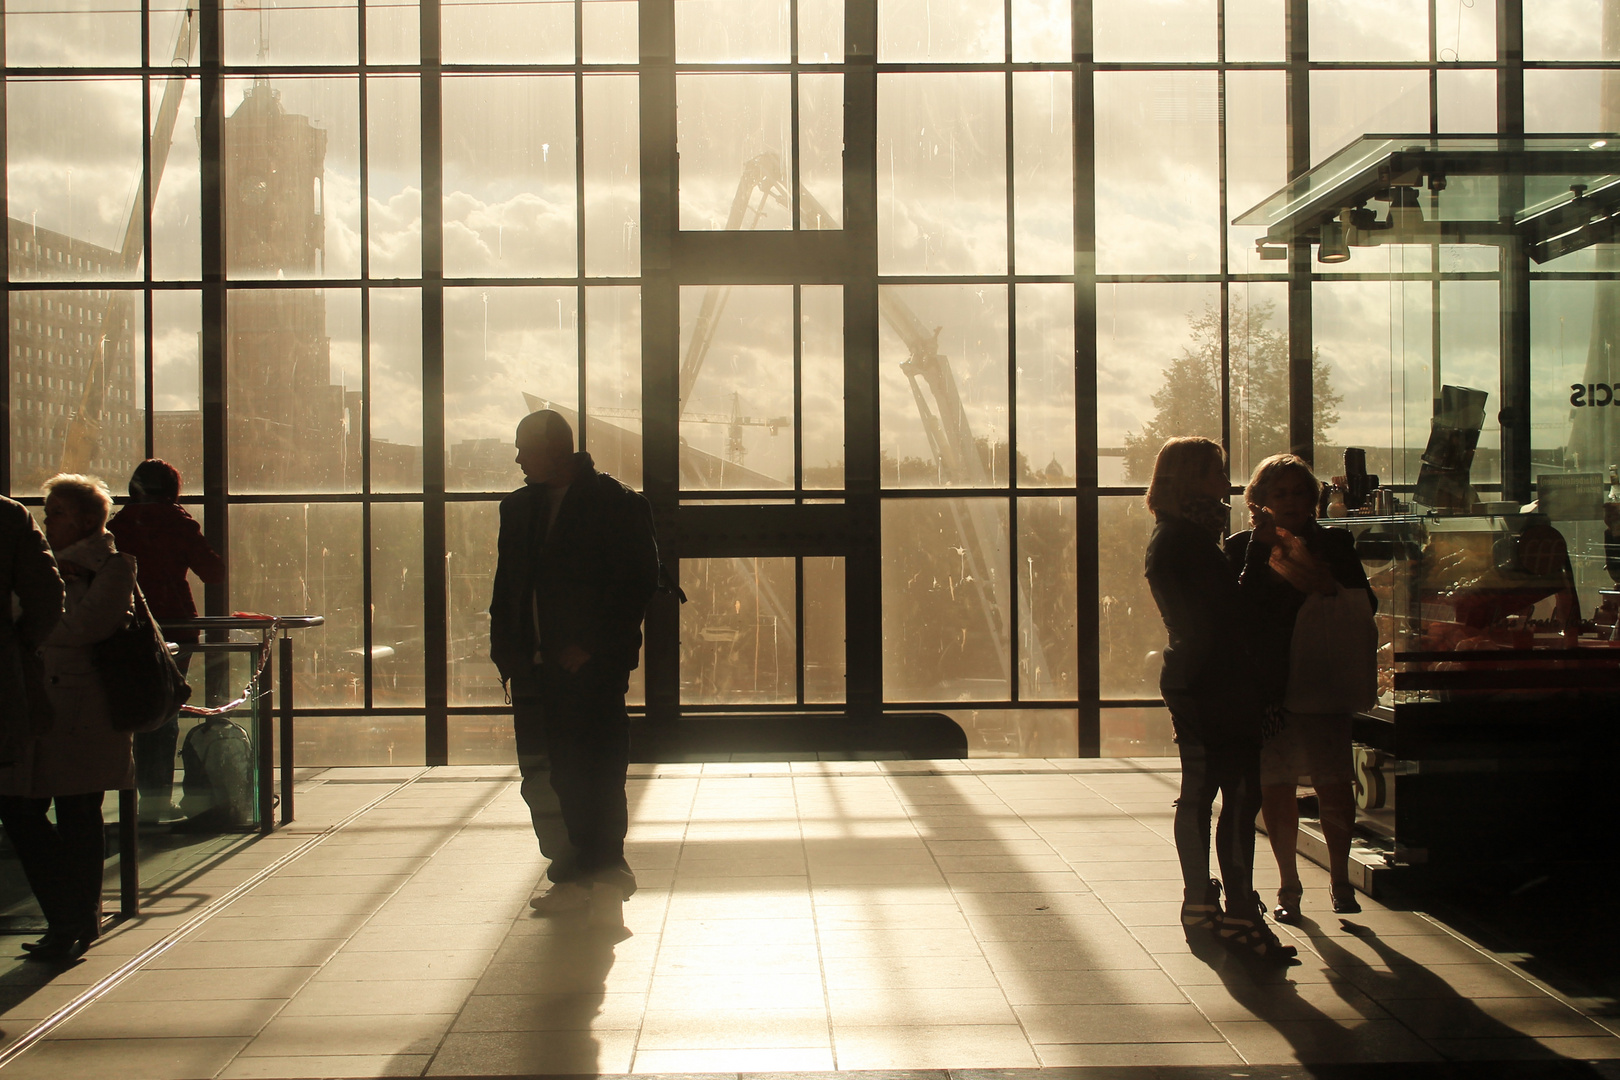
[1226,453,1377,923]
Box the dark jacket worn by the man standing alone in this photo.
[489,453,658,680]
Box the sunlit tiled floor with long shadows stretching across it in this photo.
[0,761,1620,1080]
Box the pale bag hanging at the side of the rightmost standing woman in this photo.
[1283,588,1379,712]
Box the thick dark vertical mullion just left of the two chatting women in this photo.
[1069,0,1102,758]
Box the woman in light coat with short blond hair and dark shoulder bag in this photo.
[0,473,134,962]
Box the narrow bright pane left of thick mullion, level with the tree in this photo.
[1017,285,1074,487]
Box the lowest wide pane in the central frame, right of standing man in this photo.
[680,559,799,704]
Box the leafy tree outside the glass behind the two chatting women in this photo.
[1124,301,1343,484]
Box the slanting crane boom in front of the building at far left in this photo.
[60,5,196,473]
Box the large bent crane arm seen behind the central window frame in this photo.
[680,151,1051,693]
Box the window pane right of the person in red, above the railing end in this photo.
[230,504,362,712]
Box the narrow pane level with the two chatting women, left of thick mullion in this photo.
[1014,499,1081,701]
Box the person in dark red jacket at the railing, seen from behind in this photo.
[107,458,225,821]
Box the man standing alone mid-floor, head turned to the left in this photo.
[489,410,658,926]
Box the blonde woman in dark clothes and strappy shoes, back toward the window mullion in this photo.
[1145,437,1296,963]
